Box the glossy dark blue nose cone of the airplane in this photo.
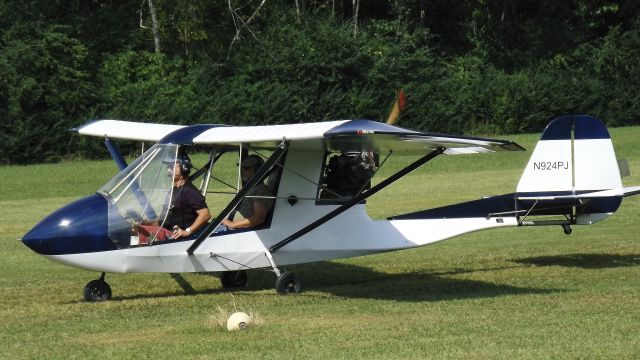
[22,194,116,255]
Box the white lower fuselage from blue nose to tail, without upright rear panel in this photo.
[47,215,518,273]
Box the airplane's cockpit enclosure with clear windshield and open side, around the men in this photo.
[98,144,281,249]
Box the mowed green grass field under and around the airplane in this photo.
[0,127,640,359]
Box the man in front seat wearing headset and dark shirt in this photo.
[138,154,211,244]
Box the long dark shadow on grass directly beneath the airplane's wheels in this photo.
[104,262,562,302]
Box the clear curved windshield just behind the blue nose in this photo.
[98,144,178,248]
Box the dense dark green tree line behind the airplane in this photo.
[0,0,640,164]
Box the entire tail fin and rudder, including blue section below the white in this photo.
[516,115,625,224]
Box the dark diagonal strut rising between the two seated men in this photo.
[187,139,287,255]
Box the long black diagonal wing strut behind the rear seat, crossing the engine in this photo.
[269,147,446,253]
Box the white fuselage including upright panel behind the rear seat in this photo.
[43,144,517,273]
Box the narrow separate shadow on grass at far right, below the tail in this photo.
[511,254,640,269]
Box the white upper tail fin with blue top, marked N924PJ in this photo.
[516,115,622,194]
